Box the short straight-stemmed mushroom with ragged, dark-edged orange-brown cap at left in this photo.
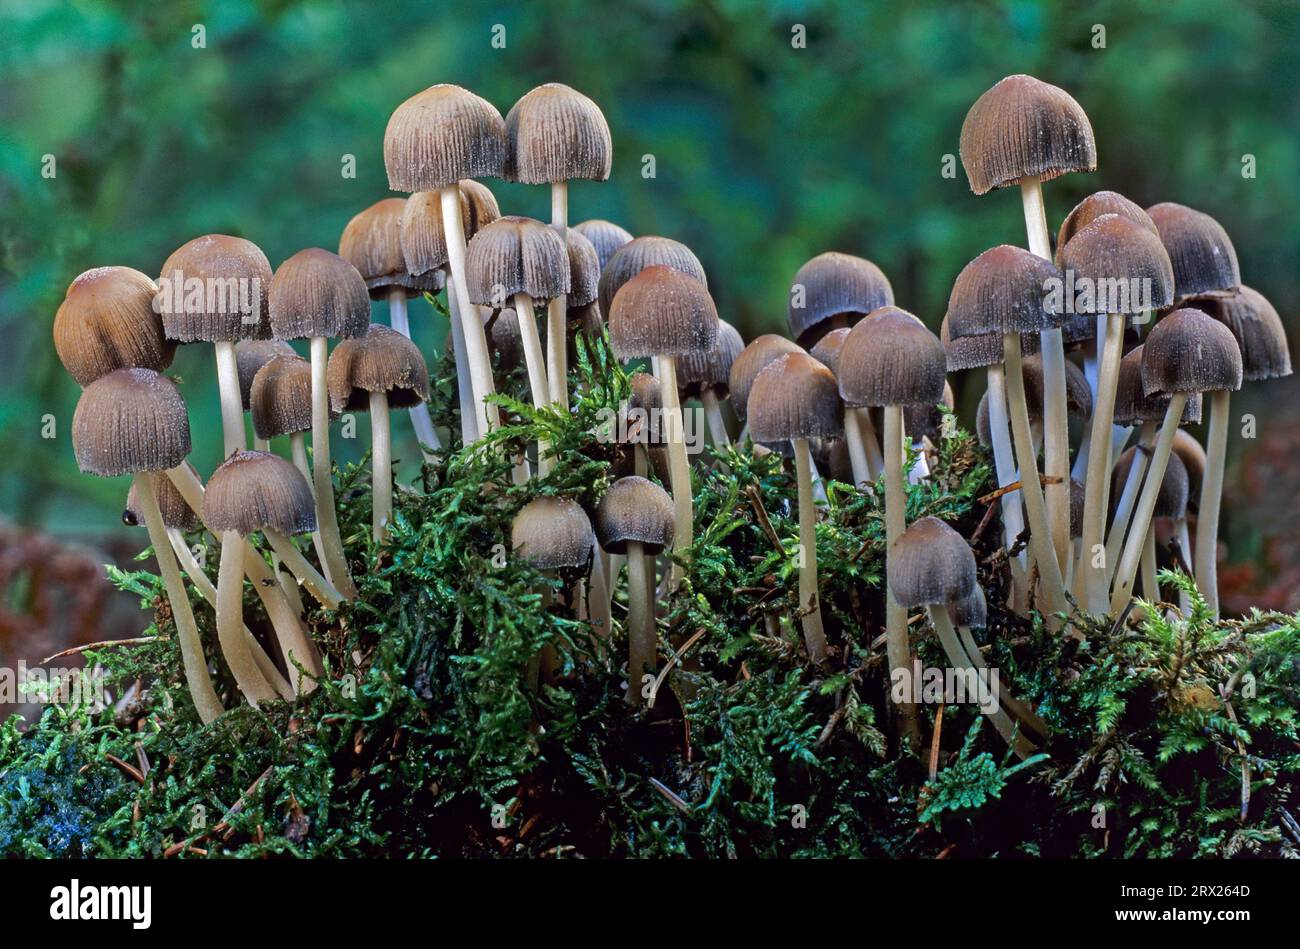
[328,324,429,543]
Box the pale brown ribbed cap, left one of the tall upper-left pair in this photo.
[384,83,506,194]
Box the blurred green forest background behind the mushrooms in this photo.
[0,0,1300,553]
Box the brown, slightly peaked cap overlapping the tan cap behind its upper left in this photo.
[745,352,844,442]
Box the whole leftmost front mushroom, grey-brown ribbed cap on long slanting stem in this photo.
[73,368,224,724]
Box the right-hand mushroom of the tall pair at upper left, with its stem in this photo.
[502,82,614,408]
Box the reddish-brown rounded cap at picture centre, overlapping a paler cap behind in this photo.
[608,263,719,361]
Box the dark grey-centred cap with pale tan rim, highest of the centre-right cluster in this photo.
[785,251,893,346]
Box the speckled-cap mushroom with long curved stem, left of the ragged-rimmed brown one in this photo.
[263,247,371,599]
